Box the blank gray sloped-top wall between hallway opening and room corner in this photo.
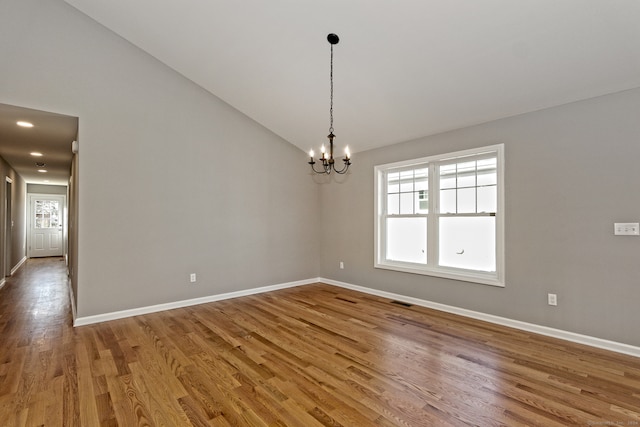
[0,0,319,317]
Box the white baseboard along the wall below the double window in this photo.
[317,277,640,357]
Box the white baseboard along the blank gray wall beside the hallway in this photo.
[73,278,318,326]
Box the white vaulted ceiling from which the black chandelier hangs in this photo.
[65,0,640,152]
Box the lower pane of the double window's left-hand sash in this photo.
[387,218,427,264]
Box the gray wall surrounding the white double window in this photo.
[321,90,640,346]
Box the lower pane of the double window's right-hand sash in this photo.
[439,217,496,272]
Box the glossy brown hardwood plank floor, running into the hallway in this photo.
[0,259,640,427]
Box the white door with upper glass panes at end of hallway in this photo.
[28,194,65,258]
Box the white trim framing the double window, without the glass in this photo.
[374,144,505,287]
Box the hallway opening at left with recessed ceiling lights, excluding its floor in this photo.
[0,103,79,317]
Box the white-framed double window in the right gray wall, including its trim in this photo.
[375,145,504,286]
